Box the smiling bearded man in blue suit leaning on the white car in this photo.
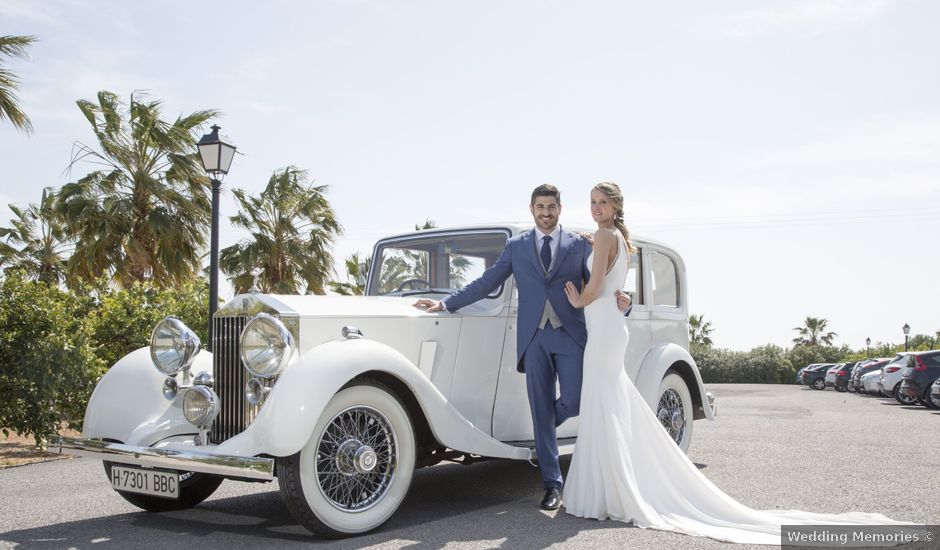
[415,185,629,510]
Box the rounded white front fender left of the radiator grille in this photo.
[82,347,212,447]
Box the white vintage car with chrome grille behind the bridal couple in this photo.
[59,225,716,537]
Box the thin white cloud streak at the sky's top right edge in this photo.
[723,0,892,36]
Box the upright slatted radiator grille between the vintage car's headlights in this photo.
[209,317,259,443]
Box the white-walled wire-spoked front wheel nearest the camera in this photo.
[277,381,415,538]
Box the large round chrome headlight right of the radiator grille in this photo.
[239,313,296,378]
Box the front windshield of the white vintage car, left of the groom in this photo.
[369,231,508,298]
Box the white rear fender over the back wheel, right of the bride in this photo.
[636,342,715,420]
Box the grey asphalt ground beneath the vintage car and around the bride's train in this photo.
[0,384,940,550]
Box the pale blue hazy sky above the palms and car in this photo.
[0,0,940,349]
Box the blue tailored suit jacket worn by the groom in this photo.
[444,229,591,372]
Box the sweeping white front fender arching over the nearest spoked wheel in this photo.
[216,338,532,460]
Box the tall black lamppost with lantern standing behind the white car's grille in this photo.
[196,124,235,351]
